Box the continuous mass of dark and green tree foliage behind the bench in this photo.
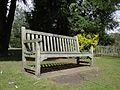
[27,0,120,45]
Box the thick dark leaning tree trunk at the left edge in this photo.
[0,0,26,56]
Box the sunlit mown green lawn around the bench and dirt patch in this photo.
[0,57,120,90]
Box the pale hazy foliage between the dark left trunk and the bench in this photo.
[10,7,28,48]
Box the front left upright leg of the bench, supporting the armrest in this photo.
[35,42,41,76]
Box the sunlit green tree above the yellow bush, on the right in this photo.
[69,0,120,45]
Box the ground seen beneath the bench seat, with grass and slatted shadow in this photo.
[25,58,90,74]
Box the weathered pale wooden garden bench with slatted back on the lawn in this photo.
[21,27,93,76]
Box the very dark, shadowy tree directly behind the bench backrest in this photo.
[27,0,76,35]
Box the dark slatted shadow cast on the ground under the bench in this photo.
[25,63,90,75]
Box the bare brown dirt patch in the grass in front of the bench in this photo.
[50,69,98,85]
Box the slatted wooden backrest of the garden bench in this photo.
[22,27,79,52]
